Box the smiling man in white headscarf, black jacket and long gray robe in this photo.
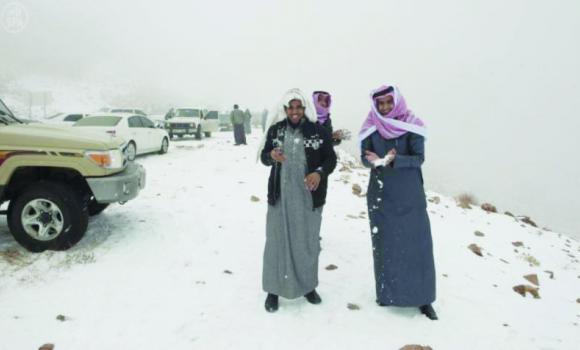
[259,89,336,312]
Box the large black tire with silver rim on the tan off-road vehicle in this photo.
[8,181,89,252]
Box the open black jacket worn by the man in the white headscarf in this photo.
[260,118,336,209]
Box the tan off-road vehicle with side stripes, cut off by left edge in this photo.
[0,99,145,252]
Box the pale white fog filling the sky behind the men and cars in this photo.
[0,0,580,238]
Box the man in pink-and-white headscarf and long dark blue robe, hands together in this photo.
[359,85,437,320]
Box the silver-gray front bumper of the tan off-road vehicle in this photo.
[87,163,146,203]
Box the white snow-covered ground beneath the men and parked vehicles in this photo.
[0,133,580,350]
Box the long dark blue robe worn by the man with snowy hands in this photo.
[362,132,435,306]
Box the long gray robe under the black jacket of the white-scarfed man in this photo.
[262,126,322,299]
